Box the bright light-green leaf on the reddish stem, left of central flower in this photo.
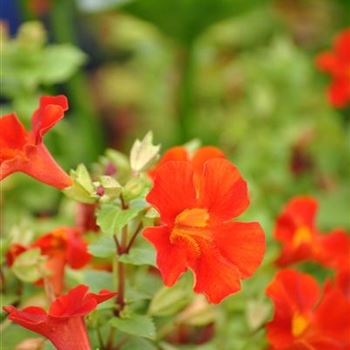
[97,204,141,235]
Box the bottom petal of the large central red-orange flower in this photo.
[191,247,241,304]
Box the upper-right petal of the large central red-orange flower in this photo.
[199,159,249,220]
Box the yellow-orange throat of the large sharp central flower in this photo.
[170,208,211,257]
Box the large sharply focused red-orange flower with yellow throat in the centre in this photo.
[144,159,265,303]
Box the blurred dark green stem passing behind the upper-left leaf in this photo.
[51,0,104,162]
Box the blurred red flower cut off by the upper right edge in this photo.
[316,28,350,107]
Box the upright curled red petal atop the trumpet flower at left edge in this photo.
[32,95,68,144]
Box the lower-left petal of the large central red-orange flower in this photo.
[143,226,187,287]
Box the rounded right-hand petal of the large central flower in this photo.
[212,222,265,278]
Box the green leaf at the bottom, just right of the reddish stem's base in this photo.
[109,314,156,339]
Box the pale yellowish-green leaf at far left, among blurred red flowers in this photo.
[11,248,45,282]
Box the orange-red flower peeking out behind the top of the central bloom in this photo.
[149,146,225,182]
